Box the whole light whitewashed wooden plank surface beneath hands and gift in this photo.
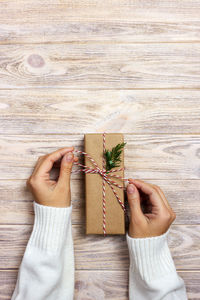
[0,0,200,300]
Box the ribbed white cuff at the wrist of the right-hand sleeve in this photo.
[126,230,176,281]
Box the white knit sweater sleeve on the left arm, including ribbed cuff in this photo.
[11,202,74,300]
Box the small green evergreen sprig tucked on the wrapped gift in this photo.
[103,143,126,171]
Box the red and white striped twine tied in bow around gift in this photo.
[73,132,128,236]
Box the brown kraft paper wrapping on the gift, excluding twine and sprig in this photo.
[84,133,125,235]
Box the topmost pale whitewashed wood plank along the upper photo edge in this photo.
[0,0,200,44]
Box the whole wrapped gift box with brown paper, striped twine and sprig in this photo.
[84,133,125,235]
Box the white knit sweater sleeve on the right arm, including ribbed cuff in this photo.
[126,230,187,300]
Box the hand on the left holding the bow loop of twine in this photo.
[26,147,78,207]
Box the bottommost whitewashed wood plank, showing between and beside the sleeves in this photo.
[0,270,200,300]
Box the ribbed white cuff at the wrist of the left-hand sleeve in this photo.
[28,202,72,253]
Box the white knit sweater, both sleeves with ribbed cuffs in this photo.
[11,202,187,300]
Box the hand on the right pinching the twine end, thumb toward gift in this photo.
[127,178,176,238]
